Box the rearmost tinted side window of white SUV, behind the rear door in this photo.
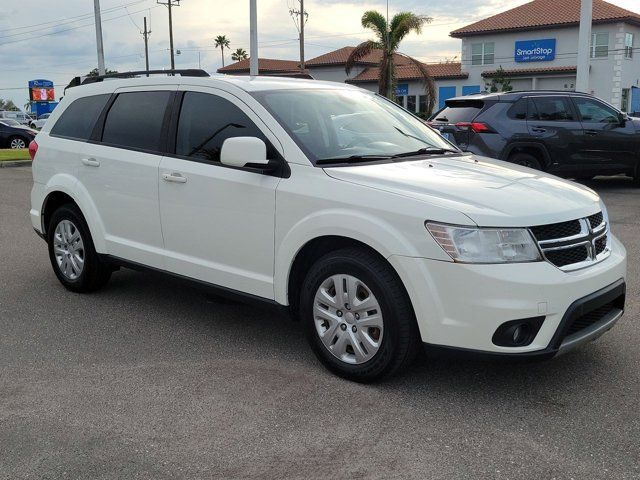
[51,94,111,140]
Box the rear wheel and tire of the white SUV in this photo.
[47,204,112,293]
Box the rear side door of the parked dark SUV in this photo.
[527,95,584,172]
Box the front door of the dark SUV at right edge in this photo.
[573,97,640,173]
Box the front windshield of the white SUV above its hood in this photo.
[254,89,455,163]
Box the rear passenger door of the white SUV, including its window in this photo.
[78,86,176,268]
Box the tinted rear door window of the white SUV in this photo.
[102,92,171,152]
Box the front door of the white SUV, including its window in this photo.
[160,87,284,298]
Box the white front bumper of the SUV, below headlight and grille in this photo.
[389,237,626,357]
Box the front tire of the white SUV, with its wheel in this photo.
[300,248,421,383]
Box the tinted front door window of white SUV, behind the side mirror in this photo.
[176,92,273,162]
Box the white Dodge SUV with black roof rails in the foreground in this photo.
[31,72,626,382]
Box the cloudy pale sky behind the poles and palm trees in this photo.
[0,0,640,106]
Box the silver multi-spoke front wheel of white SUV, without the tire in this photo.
[313,274,384,365]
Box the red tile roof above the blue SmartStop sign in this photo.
[449,0,640,38]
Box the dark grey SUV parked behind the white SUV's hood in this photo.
[430,91,640,182]
